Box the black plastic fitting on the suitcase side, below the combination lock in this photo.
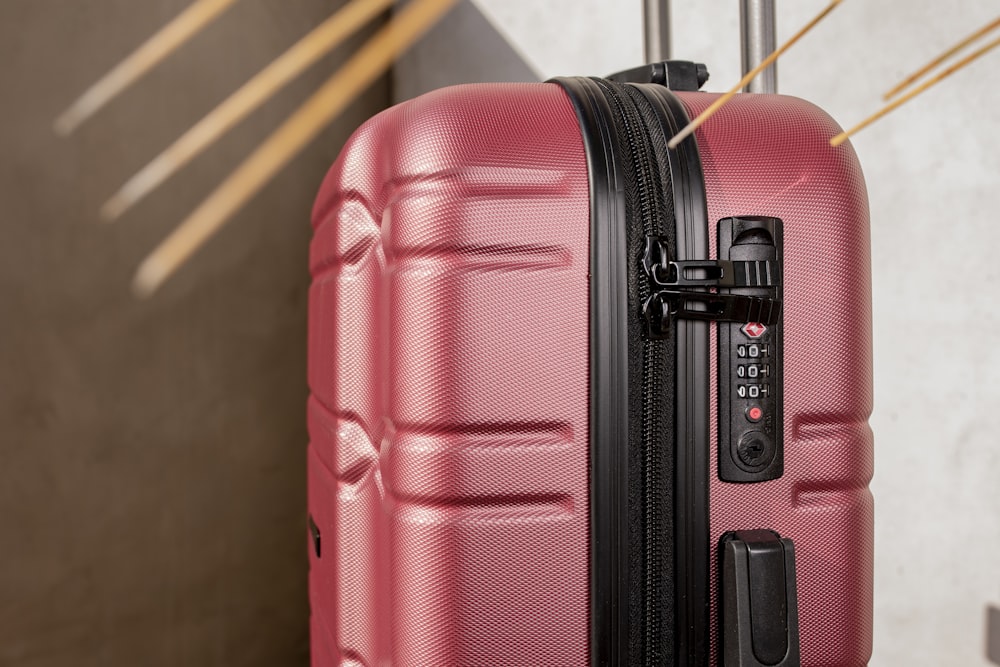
[721,530,801,667]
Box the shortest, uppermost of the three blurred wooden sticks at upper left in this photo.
[55,0,239,136]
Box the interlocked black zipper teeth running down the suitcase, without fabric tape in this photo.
[602,82,663,665]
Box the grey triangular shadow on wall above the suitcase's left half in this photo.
[393,0,541,102]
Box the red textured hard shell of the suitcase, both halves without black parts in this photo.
[308,77,872,666]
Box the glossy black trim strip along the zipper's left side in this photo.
[555,78,631,665]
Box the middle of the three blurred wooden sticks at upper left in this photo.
[101,0,393,222]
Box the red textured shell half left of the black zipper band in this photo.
[309,84,590,667]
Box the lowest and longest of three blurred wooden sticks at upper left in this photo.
[132,0,458,297]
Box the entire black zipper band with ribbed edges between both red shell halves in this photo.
[556,77,712,667]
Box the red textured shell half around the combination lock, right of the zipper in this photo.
[680,93,873,667]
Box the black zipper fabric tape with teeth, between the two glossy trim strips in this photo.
[599,82,676,667]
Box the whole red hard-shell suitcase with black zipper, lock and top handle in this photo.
[309,17,872,666]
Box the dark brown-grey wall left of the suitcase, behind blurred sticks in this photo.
[0,0,388,667]
